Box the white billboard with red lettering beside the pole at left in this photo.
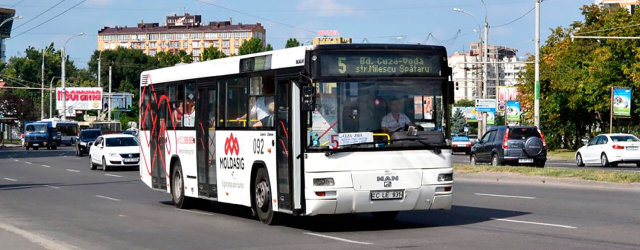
[56,87,102,113]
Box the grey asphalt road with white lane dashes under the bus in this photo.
[0,147,640,250]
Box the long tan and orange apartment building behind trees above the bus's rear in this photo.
[98,13,266,61]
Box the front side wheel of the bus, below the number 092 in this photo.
[252,167,278,225]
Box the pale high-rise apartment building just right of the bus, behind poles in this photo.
[449,43,525,101]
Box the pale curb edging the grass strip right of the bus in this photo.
[453,172,640,191]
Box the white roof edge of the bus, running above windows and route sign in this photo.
[140,43,446,86]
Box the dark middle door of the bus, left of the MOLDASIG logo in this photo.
[196,85,218,198]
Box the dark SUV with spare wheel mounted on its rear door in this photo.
[470,126,547,168]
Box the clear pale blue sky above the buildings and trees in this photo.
[0,0,594,68]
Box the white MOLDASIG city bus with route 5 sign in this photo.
[138,44,454,224]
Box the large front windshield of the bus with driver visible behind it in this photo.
[307,80,446,148]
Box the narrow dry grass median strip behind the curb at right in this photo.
[453,165,640,183]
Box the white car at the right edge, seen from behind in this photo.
[576,134,640,167]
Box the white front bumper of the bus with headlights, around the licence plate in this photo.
[306,183,452,216]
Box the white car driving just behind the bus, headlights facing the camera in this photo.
[89,134,140,171]
